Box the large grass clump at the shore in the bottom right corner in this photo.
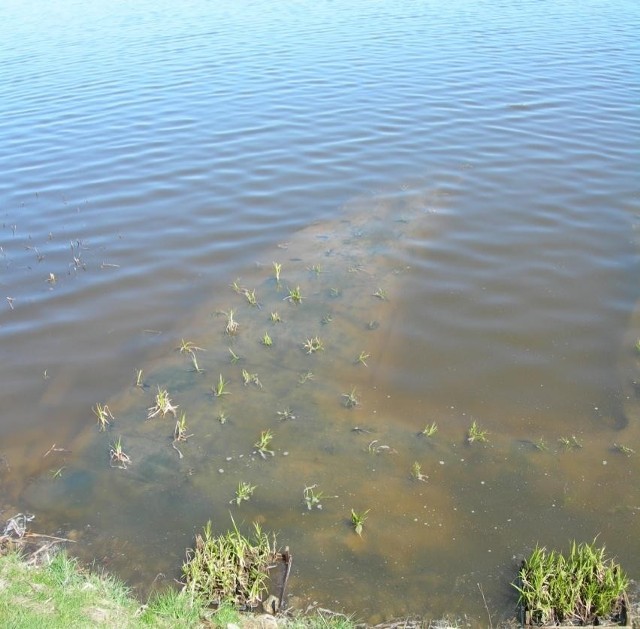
[513,540,629,625]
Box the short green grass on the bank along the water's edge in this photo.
[0,551,355,629]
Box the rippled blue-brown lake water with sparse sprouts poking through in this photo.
[0,0,640,626]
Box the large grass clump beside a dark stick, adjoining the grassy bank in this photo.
[182,520,278,608]
